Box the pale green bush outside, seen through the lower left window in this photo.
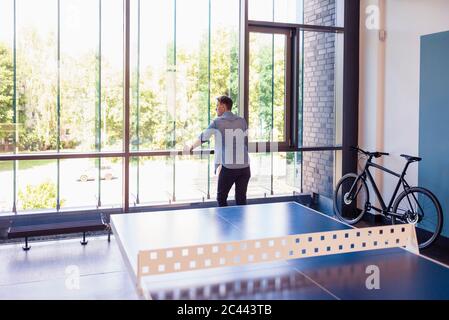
[19,181,65,210]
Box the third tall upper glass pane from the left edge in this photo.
[60,0,98,152]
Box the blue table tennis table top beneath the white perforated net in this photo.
[111,202,449,300]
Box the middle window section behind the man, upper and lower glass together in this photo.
[130,0,240,205]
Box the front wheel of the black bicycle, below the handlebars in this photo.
[334,174,369,225]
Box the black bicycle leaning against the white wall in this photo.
[333,147,443,249]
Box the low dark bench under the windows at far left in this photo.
[8,213,111,251]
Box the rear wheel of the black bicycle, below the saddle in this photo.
[391,188,443,249]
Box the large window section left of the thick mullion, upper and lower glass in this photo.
[0,0,123,212]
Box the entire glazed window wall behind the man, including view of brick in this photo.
[0,0,344,214]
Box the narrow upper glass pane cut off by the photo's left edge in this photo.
[0,0,15,155]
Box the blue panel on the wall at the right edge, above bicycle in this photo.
[419,32,449,237]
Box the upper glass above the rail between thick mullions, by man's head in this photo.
[131,0,240,150]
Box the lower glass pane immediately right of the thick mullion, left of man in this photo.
[129,157,175,206]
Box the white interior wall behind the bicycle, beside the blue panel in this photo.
[359,0,449,197]
